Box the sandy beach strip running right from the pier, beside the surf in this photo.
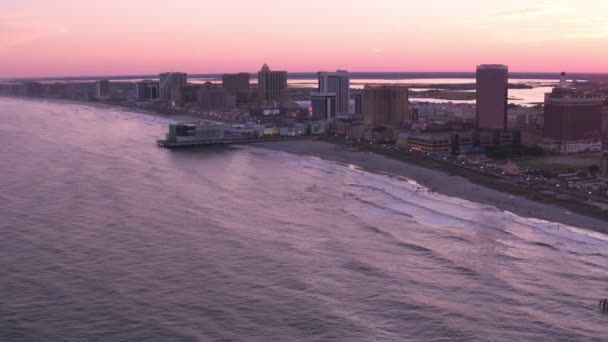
[253,140,608,234]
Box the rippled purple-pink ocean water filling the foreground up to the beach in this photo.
[0,98,608,341]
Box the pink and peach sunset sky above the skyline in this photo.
[0,0,608,78]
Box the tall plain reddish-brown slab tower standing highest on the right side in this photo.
[476,64,509,130]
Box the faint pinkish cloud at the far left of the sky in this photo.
[0,12,68,50]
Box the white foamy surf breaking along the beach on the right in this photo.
[255,147,608,247]
